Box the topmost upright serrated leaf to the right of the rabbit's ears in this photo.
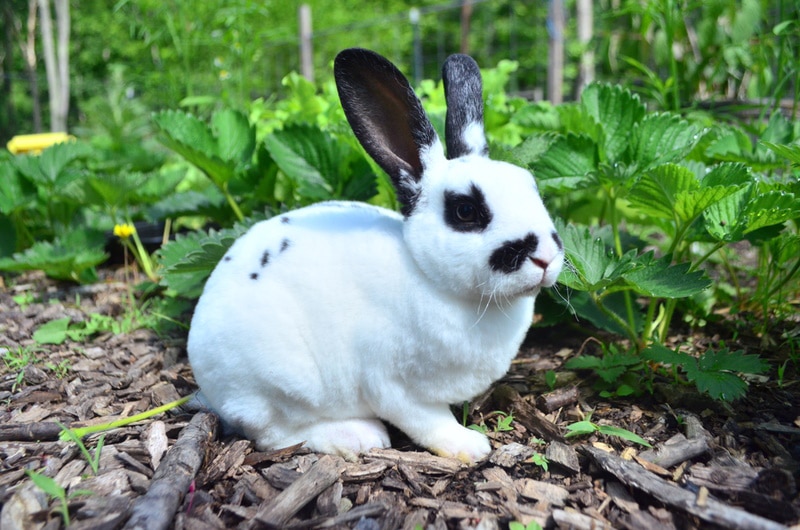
[581,83,646,163]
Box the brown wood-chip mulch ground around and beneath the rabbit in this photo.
[0,271,800,530]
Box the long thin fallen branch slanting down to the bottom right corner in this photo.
[579,445,786,530]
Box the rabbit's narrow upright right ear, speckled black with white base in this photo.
[442,54,489,159]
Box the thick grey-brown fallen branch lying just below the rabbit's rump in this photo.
[125,412,217,530]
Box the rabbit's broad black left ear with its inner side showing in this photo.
[333,48,441,215]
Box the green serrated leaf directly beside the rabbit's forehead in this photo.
[531,134,597,191]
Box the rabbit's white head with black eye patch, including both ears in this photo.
[334,49,563,302]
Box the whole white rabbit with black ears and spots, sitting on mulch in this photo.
[187,48,564,463]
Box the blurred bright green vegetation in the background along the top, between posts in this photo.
[0,0,800,144]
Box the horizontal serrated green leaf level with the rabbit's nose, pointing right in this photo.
[623,252,711,298]
